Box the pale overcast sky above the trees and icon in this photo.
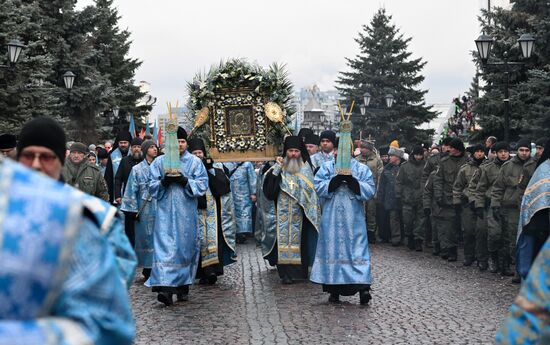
[78,0,484,114]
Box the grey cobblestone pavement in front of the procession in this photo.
[131,244,519,345]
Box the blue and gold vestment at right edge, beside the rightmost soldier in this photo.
[516,160,550,278]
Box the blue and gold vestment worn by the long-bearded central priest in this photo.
[262,164,321,265]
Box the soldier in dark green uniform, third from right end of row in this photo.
[453,145,487,266]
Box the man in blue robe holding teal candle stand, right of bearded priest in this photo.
[310,112,376,305]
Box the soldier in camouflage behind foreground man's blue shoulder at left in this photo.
[61,143,109,201]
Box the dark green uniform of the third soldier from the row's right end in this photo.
[453,158,482,264]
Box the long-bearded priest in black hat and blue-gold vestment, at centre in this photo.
[261,136,321,284]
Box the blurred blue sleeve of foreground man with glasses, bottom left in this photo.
[0,221,135,345]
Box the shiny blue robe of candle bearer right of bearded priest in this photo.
[310,159,376,285]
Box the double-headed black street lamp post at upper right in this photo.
[475,34,535,142]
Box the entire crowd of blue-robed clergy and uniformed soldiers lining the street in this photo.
[0,116,550,344]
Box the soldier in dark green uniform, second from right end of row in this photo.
[474,141,510,273]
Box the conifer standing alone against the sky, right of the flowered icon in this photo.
[336,9,436,145]
